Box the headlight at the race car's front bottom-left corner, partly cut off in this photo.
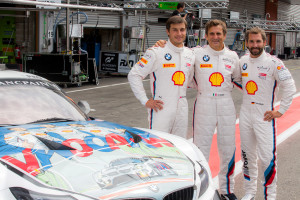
[9,187,78,200]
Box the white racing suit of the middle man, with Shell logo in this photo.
[193,45,241,194]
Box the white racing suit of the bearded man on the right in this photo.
[240,52,296,200]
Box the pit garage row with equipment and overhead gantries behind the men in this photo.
[0,0,300,86]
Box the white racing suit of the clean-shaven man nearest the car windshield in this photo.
[128,41,195,138]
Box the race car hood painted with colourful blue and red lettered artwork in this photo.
[0,120,194,199]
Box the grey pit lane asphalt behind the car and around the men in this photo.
[64,59,300,200]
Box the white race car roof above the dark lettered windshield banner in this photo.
[0,70,47,81]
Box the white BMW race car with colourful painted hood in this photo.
[0,71,220,200]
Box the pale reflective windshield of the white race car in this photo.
[0,85,86,126]
